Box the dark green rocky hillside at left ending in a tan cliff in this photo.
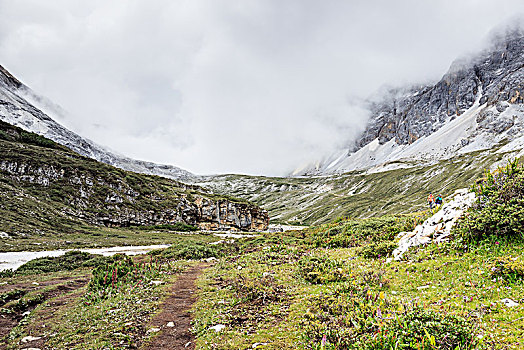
[0,122,269,235]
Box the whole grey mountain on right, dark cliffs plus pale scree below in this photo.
[306,22,524,174]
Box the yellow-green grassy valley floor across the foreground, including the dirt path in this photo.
[0,226,524,349]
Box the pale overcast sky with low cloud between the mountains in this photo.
[0,0,524,175]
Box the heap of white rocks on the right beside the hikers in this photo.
[392,189,475,260]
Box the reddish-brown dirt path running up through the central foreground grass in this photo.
[141,264,209,350]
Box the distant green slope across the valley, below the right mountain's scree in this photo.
[201,149,511,224]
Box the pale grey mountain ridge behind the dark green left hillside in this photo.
[0,66,194,181]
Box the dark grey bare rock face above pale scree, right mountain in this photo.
[356,29,524,149]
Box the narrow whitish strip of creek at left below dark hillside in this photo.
[0,244,169,271]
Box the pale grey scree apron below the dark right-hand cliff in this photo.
[321,89,524,173]
